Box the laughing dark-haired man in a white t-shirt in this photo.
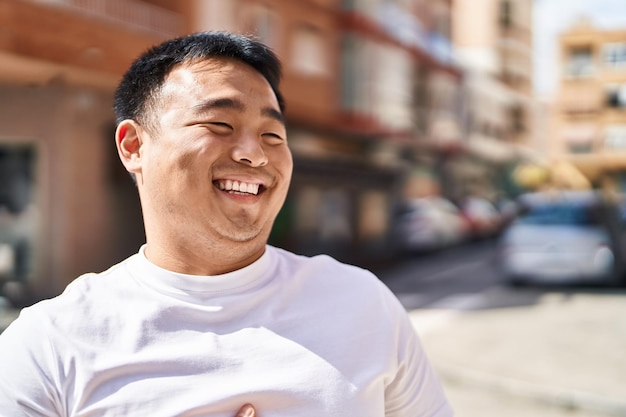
[0,32,452,417]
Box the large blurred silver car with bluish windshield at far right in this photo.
[497,191,626,284]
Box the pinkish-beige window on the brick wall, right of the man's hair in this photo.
[291,25,330,75]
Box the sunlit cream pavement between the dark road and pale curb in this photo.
[410,291,626,417]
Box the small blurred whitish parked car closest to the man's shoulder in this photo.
[392,197,466,252]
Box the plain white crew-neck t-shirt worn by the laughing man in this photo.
[0,246,453,417]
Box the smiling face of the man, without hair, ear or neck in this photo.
[132,59,293,256]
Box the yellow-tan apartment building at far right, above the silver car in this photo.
[551,19,626,193]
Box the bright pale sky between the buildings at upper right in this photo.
[533,0,626,96]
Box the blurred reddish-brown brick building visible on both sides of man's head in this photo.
[0,0,463,297]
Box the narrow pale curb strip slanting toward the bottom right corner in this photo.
[433,363,626,417]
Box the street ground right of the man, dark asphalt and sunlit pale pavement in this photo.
[377,241,626,417]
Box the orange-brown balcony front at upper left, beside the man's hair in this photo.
[0,0,183,88]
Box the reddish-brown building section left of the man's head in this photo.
[0,0,185,301]
